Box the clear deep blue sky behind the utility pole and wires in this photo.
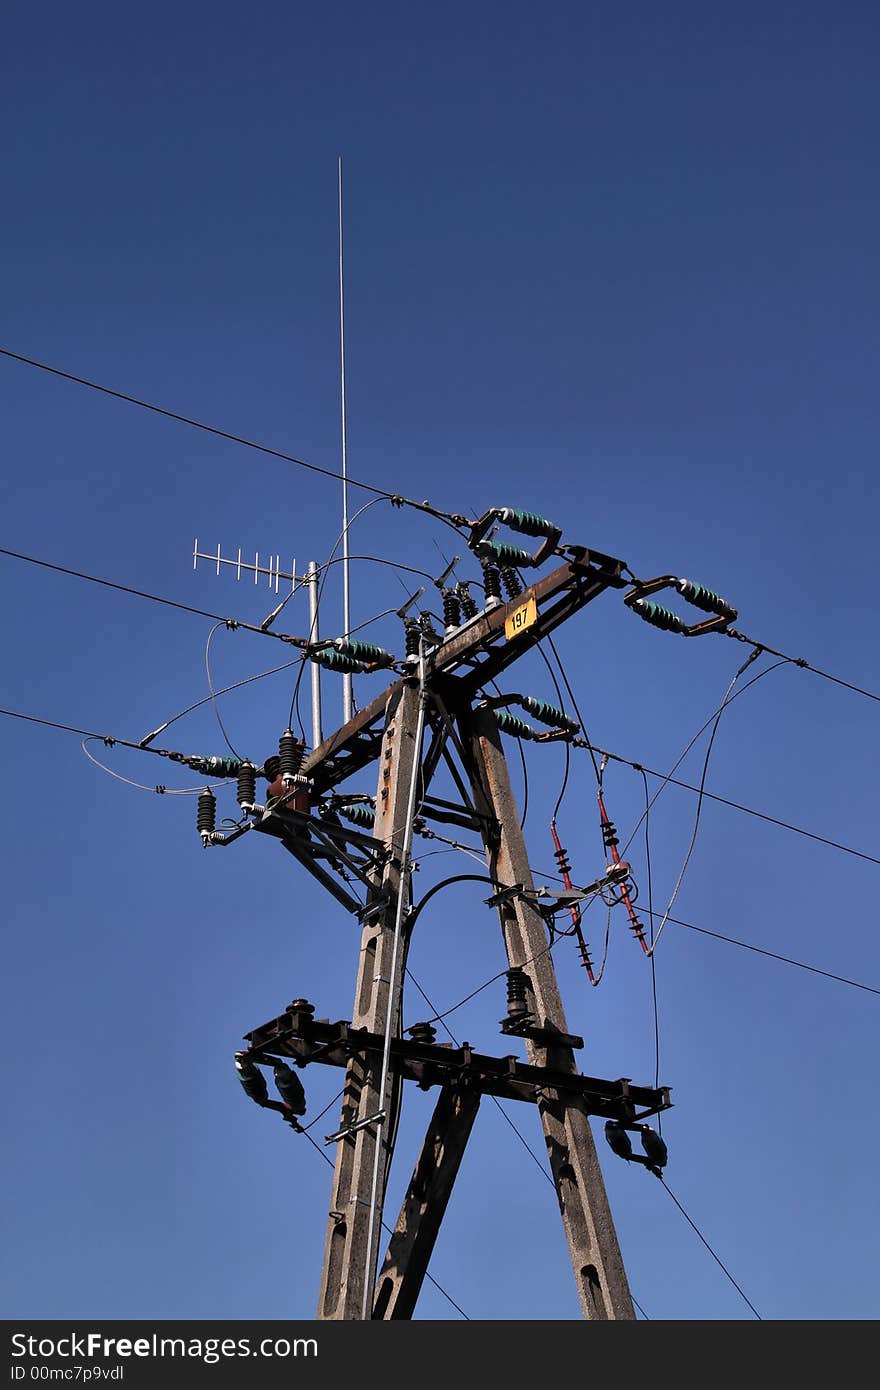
[0,0,880,1321]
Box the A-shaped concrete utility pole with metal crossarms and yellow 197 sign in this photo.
[226,509,670,1321]
